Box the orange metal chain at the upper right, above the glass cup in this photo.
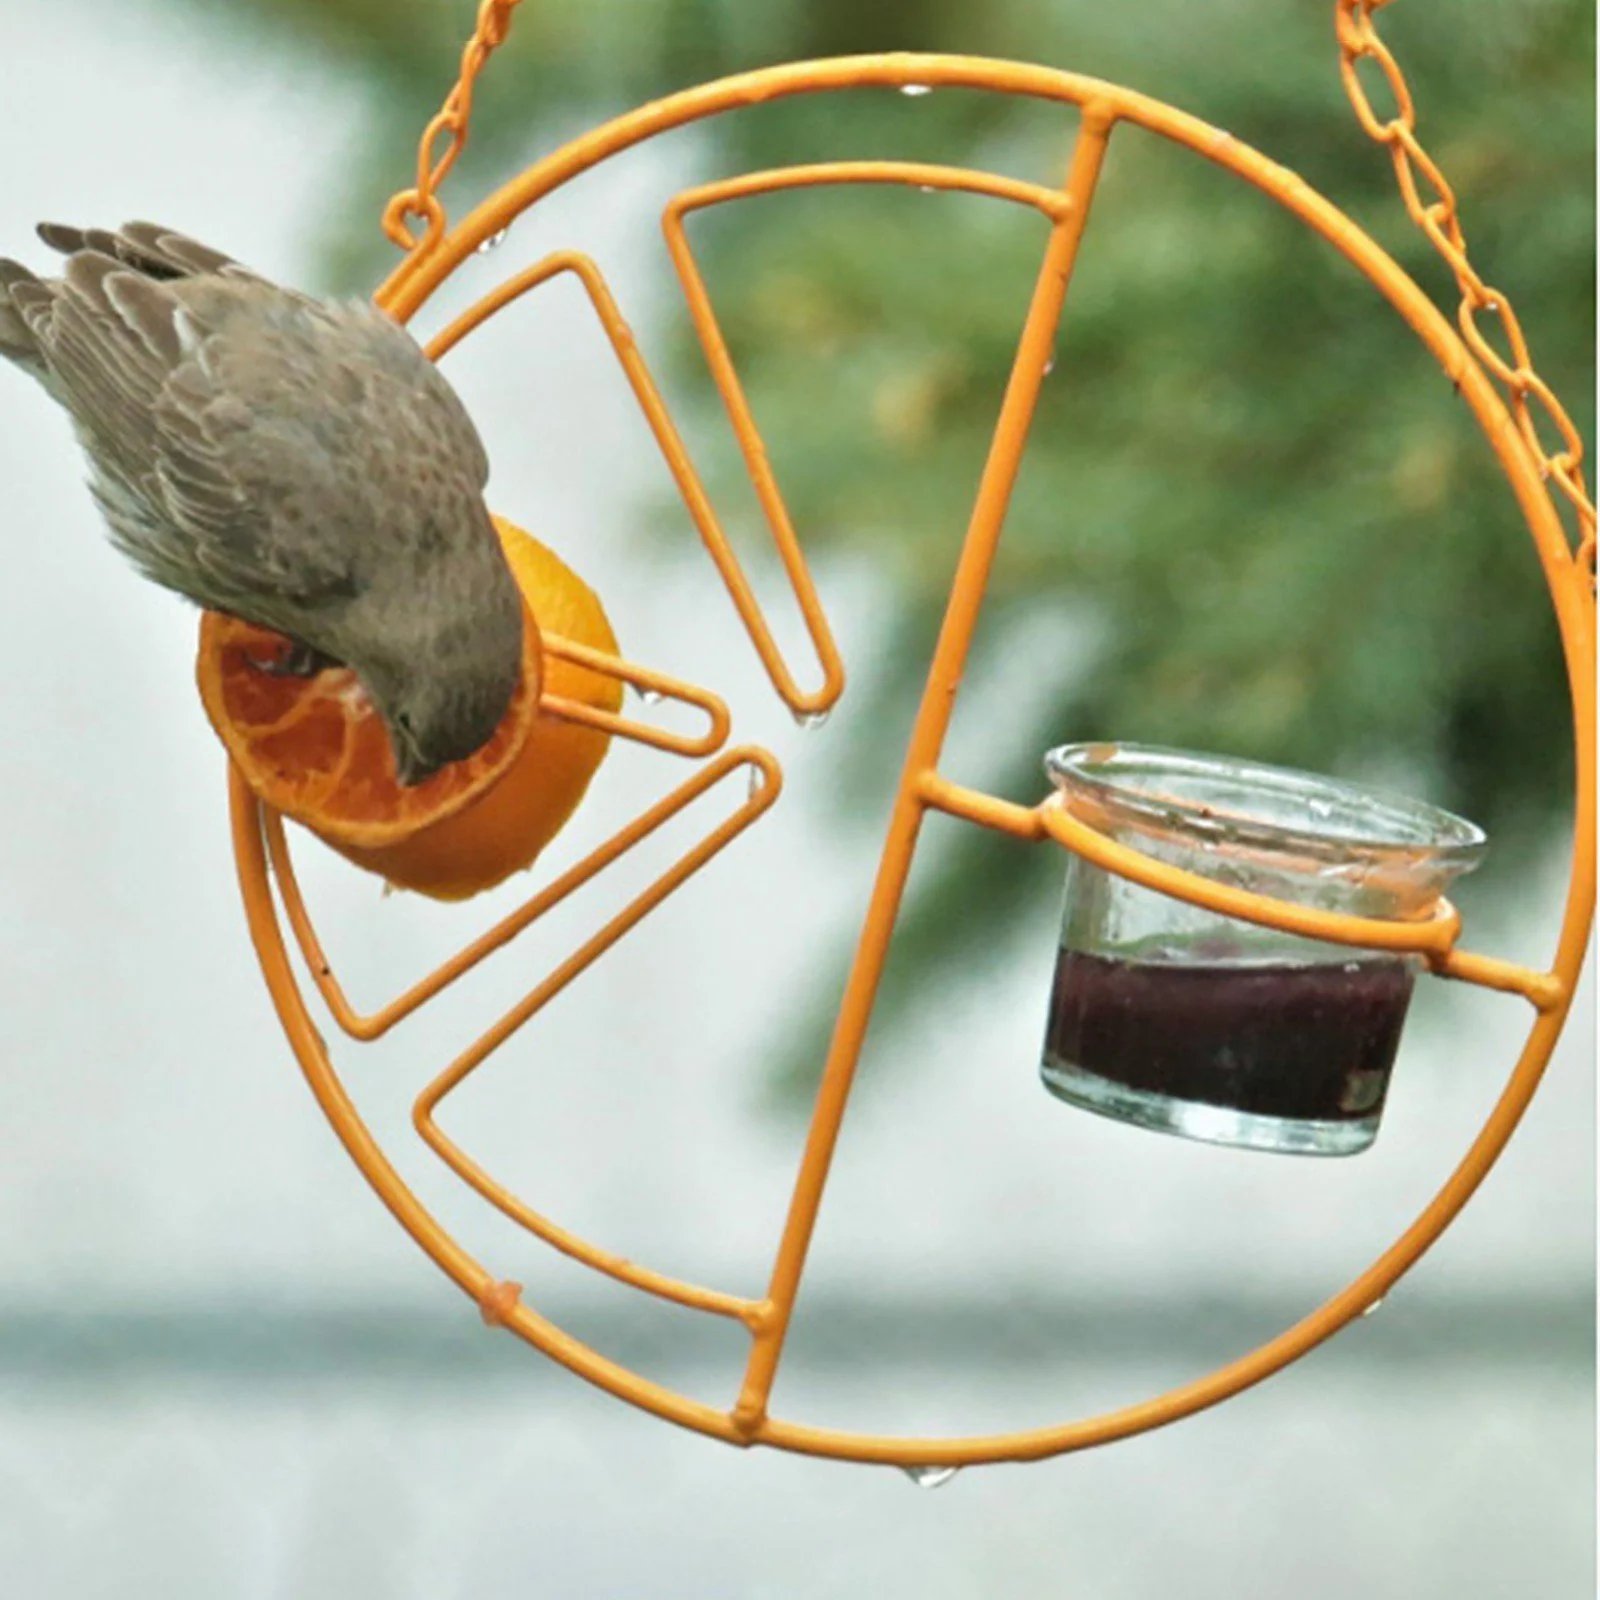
[1334,0,1595,574]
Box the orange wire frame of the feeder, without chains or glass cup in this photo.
[230,54,1595,1466]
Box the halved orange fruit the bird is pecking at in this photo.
[195,517,622,899]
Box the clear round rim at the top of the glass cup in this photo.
[1045,739,1488,872]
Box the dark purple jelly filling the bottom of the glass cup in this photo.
[1045,950,1411,1122]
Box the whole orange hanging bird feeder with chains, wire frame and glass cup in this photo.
[230,0,1595,1482]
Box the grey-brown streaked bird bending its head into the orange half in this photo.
[0,222,525,787]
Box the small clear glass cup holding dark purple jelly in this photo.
[1040,744,1485,1155]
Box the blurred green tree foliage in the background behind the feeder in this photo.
[159,0,1595,1077]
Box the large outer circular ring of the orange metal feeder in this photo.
[230,54,1595,1466]
